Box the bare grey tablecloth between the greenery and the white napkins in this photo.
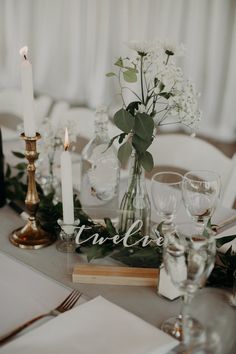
[0,206,236,354]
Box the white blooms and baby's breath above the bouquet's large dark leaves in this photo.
[109,40,201,134]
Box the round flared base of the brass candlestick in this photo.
[9,218,56,249]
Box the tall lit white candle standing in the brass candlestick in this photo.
[20,47,36,137]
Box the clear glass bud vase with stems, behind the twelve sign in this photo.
[119,151,151,235]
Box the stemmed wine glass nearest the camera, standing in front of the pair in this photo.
[161,223,216,343]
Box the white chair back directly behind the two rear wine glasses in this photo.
[148,134,236,208]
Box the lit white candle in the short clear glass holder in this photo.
[61,128,74,224]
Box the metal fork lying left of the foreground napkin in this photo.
[0,290,81,345]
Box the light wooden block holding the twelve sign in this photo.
[72,264,159,286]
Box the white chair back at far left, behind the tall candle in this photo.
[0,88,52,141]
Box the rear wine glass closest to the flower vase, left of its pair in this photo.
[151,172,183,233]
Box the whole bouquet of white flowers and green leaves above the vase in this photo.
[107,40,201,170]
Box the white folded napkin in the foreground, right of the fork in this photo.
[0,296,177,354]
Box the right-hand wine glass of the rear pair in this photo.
[182,170,221,231]
